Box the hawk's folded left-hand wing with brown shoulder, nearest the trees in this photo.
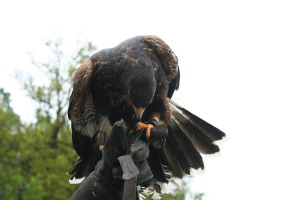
[68,60,99,157]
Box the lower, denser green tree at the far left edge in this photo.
[0,89,43,200]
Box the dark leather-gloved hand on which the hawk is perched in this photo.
[70,120,167,200]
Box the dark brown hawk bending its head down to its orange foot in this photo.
[68,35,225,182]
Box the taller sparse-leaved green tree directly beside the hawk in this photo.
[17,38,95,200]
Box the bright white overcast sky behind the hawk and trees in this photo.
[0,0,300,200]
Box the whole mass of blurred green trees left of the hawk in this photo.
[0,39,95,200]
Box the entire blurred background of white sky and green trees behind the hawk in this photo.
[0,0,300,200]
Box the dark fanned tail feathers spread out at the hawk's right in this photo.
[149,100,225,178]
